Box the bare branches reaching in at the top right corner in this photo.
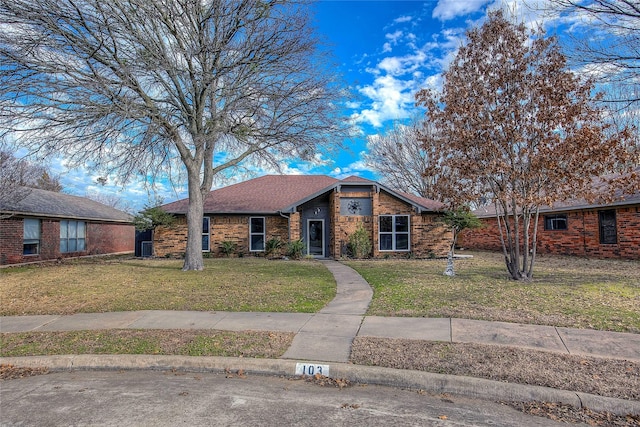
[546,0,640,109]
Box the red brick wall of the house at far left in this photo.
[0,217,135,265]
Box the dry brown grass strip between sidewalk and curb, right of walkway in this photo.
[351,337,640,400]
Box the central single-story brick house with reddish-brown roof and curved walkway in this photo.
[153,175,451,258]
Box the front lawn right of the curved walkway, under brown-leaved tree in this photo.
[348,252,640,333]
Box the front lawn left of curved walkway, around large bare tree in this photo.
[0,258,336,316]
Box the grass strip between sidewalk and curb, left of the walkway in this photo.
[0,329,294,358]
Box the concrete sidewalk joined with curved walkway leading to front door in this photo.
[0,260,640,362]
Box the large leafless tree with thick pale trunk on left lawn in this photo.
[0,0,342,270]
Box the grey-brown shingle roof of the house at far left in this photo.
[0,188,132,222]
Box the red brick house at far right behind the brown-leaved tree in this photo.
[458,193,640,259]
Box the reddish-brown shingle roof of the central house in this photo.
[162,175,443,214]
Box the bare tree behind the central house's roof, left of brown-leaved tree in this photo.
[364,119,440,199]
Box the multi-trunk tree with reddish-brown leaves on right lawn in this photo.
[417,12,640,280]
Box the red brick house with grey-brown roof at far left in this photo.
[0,189,135,265]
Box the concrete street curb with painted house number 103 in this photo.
[0,355,640,415]
